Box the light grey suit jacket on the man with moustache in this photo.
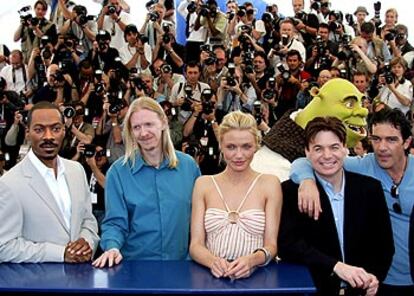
[0,156,99,262]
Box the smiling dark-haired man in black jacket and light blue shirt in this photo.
[279,117,394,296]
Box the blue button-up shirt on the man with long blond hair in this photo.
[101,152,200,260]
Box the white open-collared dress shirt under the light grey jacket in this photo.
[27,149,72,229]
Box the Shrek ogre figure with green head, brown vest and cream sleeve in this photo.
[251,78,368,182]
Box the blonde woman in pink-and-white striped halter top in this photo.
[190,111,282,279]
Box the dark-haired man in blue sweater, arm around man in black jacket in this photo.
[291,108,414,296]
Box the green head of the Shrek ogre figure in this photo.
[295,78,368,147]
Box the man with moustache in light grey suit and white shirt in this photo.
[0,102,99,263]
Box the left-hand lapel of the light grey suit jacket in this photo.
[22,157,69,233]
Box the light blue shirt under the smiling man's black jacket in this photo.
[315,172,345,262]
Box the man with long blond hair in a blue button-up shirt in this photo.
[93,97,200,267]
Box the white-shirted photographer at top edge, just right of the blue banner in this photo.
[194,0,227,44]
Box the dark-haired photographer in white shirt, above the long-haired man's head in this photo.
[119,24,152,70]
